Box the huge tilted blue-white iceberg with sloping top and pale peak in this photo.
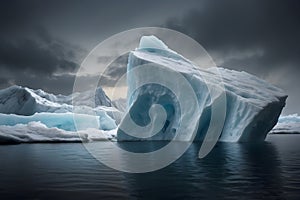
[117,36,287,142]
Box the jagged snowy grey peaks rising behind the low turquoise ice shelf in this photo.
[0,85,111,115]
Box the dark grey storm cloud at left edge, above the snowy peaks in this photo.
[0,32,77,75]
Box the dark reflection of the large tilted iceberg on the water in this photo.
[122,142,283,199]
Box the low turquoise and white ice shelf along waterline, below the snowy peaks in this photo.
[0,111,117,144]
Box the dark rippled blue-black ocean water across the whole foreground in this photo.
[0,135,300,200]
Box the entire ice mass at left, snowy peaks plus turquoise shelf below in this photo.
[0,86,122,143]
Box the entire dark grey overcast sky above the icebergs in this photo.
[0,0,300,114]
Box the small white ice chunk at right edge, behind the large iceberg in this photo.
[270,114,300,134]
